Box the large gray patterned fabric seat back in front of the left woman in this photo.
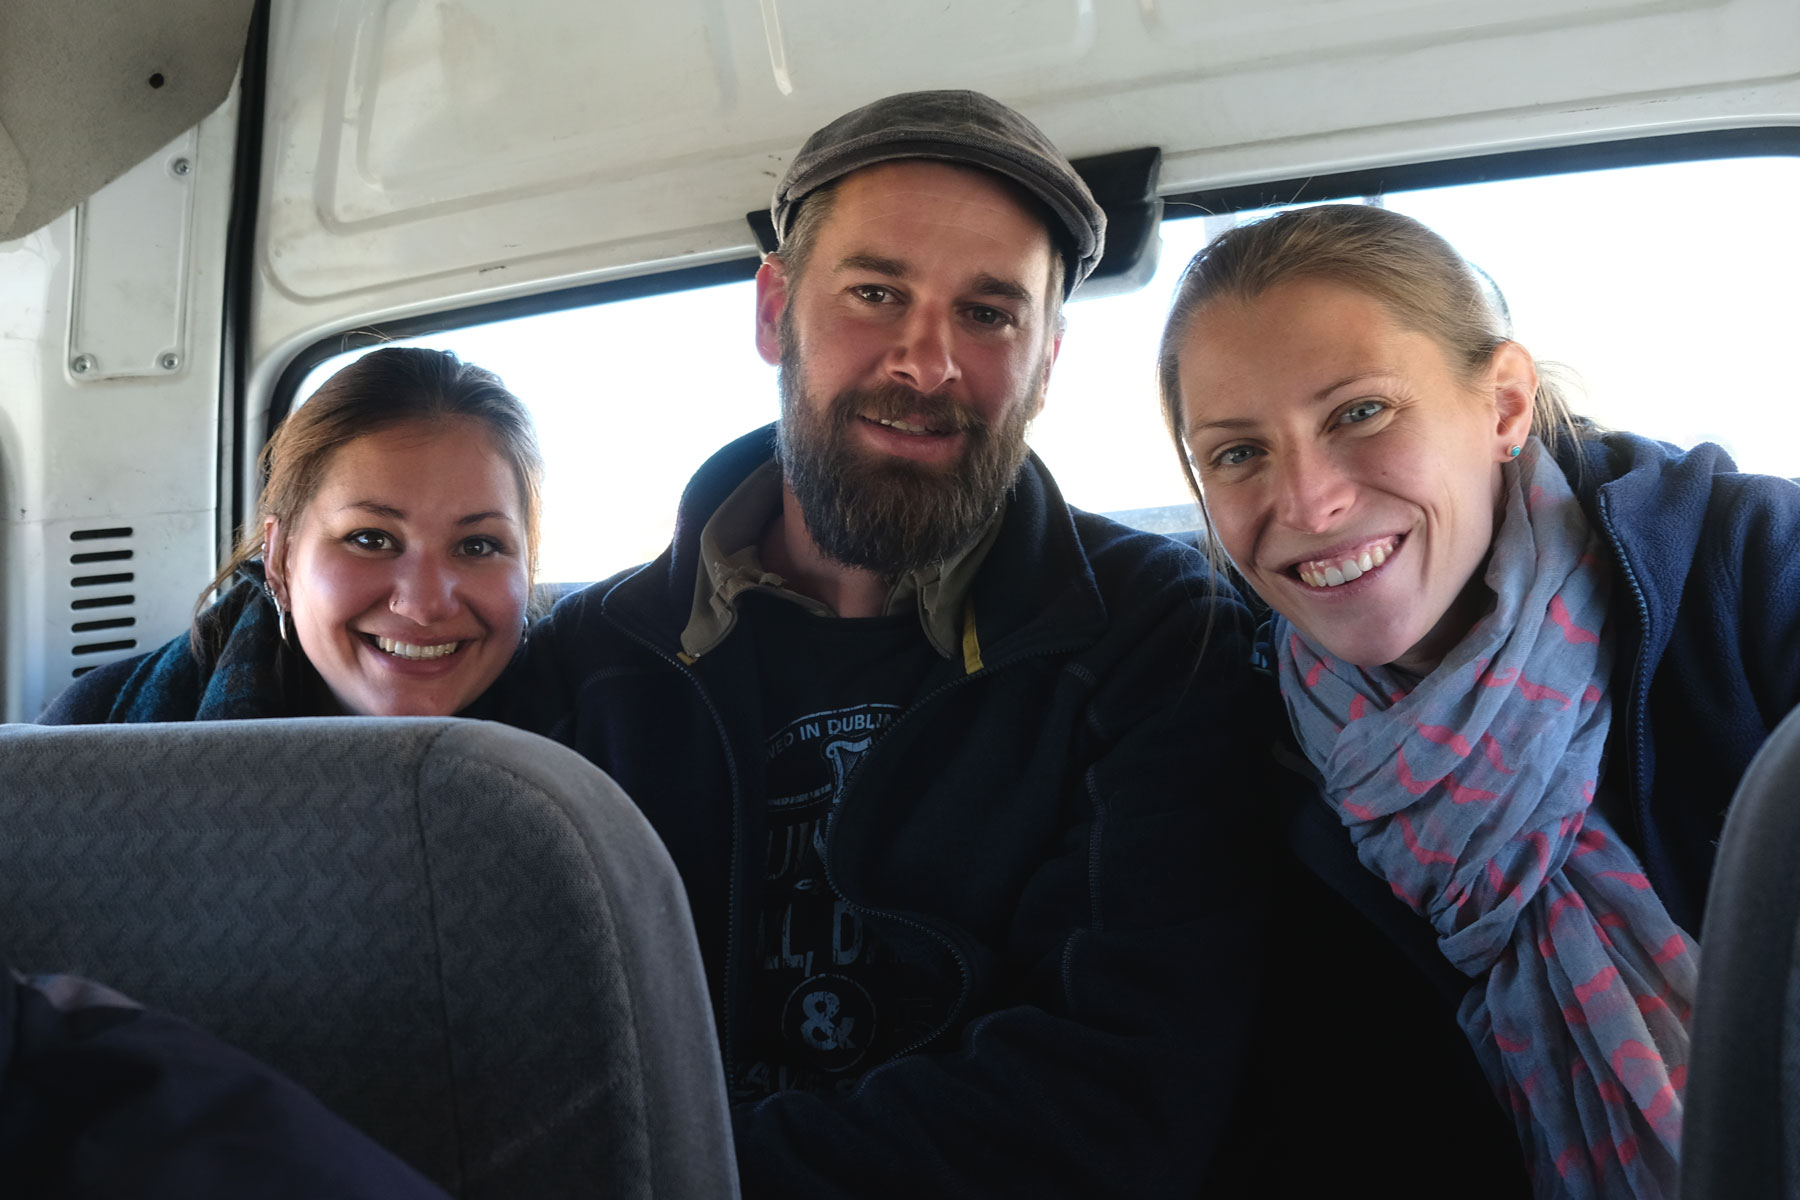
[0,718,736,1196]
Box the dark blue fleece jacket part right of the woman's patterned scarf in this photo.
[1562,434,1800,946]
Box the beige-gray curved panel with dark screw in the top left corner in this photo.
[0,0,254,241]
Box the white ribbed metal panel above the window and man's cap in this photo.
[254,0,1800,370]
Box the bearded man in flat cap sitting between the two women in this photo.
[526,92,1269,1196]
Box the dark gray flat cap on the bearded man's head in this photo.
[769,92,1107,295]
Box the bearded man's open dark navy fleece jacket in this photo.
[513,428,1274,1196]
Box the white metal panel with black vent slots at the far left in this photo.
[0,94,238,721]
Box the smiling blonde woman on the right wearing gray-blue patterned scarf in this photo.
[1159,205,1800,1196]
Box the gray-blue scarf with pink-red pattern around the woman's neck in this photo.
[1276,439,1697,1198]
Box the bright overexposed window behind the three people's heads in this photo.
[299,157,1800,583]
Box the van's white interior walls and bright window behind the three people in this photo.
[0,0,1800,1195]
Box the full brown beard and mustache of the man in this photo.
[776,329,1042,579]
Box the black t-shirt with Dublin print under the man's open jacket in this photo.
[734,594,952,1099]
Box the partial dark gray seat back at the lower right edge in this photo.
[1681,711,1800,1200]
